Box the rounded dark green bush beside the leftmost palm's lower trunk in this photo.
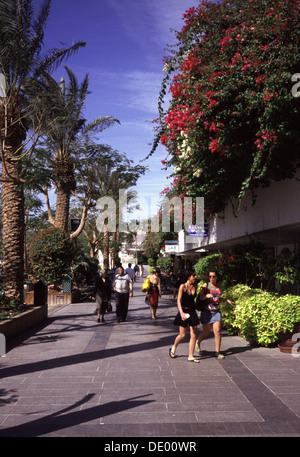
[29,227,74,284]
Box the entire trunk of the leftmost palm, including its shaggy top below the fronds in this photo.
[0,97,26,304]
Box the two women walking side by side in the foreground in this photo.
[169,271,234,363]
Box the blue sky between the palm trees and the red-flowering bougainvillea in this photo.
[36,0,199,218]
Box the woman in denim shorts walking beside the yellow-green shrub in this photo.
[195,271,234,359]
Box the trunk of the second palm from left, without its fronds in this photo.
[55,156,76,232]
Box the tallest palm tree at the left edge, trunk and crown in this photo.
[0,0,86,303]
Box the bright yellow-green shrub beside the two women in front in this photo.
[221,284,300,346]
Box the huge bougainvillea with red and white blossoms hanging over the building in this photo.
[151,0,300,215]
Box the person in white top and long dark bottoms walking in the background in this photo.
[113,267,133,322]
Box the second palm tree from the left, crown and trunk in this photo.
[40,67,119,231]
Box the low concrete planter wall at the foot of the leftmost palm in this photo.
[0,305,48,340]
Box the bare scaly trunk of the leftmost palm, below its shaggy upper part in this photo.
[2,161,25,304]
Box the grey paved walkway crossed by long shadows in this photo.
[0,280,300,439]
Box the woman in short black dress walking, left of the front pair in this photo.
[169,272,199,363]
